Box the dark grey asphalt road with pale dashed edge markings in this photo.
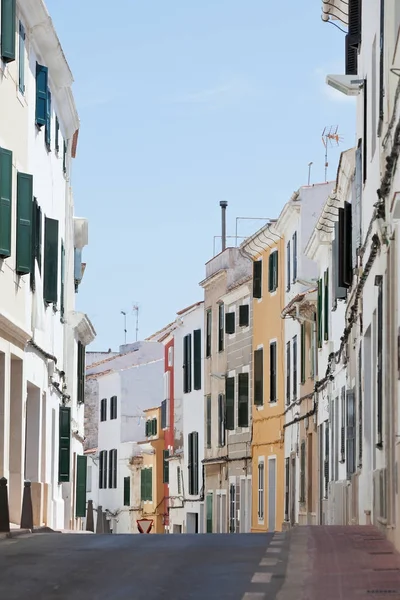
[0,533,288,600]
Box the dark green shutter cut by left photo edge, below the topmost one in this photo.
[0,148,12,258]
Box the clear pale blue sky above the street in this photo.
[47,0,355,350]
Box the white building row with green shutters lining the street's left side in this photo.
[0,0,95,529]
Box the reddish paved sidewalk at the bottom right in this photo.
[277,526,400,600]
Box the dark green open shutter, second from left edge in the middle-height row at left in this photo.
[16,173,33,275]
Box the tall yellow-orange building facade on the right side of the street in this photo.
[242,223,285,533]
